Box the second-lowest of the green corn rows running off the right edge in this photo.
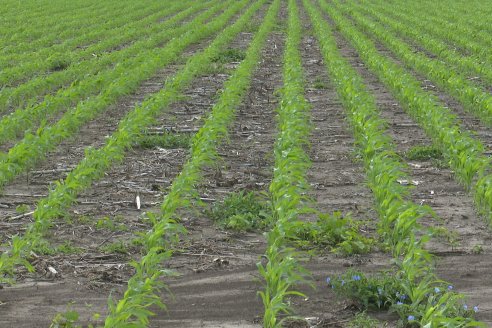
[332,0,492,126]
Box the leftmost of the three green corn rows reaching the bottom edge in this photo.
[105,0,280,328]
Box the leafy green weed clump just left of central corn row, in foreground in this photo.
[206,191,271,231]
